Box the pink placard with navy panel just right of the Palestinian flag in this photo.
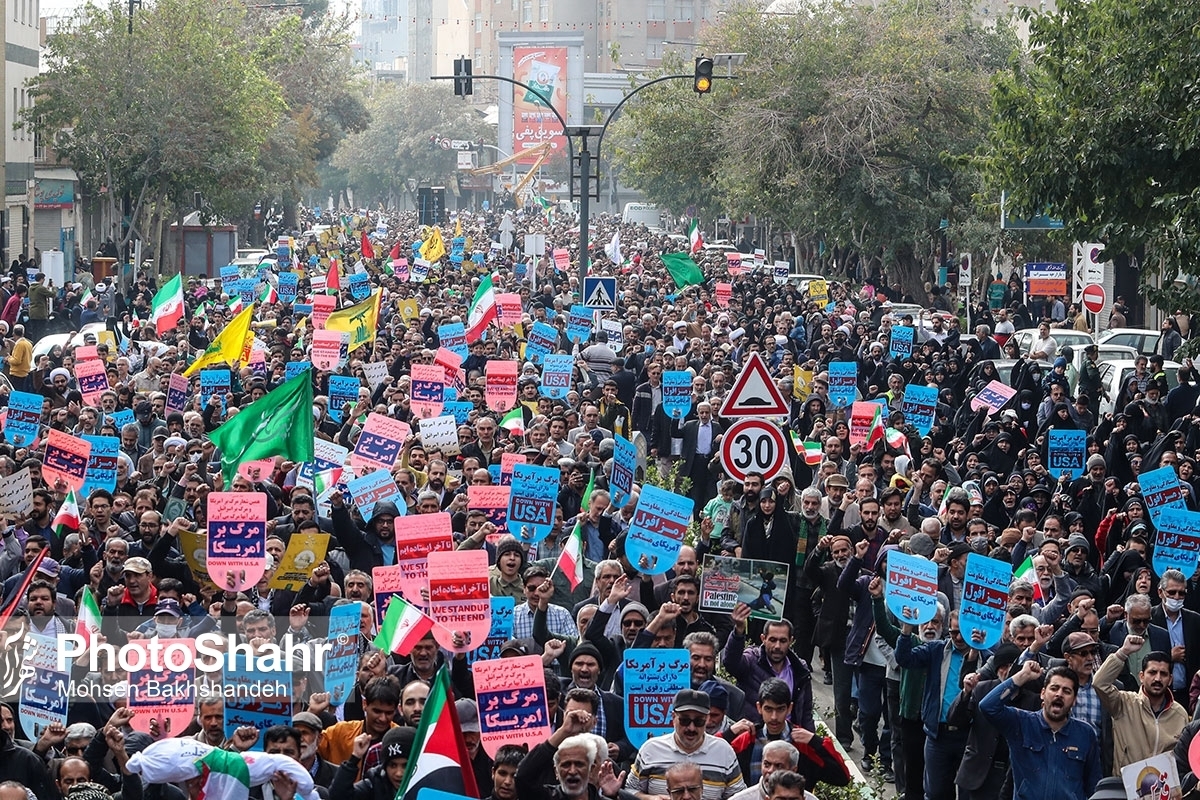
[470,656,551,758]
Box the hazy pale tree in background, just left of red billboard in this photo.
[334,84,490,204]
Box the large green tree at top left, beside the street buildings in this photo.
[26,0,283,256]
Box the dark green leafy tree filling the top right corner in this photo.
[984,0,1200,312]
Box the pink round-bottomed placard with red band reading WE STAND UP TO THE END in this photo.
[428,551,492,652]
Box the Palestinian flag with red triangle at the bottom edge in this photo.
[396,666,479,800]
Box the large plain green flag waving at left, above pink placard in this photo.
[209,371,314,488]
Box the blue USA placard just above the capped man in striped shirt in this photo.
[620,648,691,747]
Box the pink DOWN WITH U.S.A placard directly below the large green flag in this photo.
[206,492,266,591]
